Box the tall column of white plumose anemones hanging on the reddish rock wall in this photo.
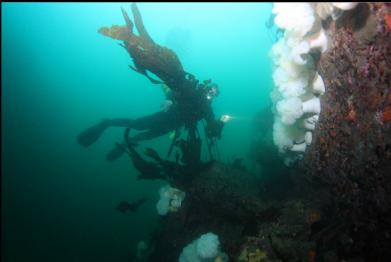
[270,3,357,165]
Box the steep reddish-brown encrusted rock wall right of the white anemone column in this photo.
[302,3,391,261]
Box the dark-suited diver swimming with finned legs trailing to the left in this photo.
[77,83,223,161]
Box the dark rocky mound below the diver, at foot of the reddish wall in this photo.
[149,162,326,261]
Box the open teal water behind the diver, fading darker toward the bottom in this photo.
[1,3,272,262]
